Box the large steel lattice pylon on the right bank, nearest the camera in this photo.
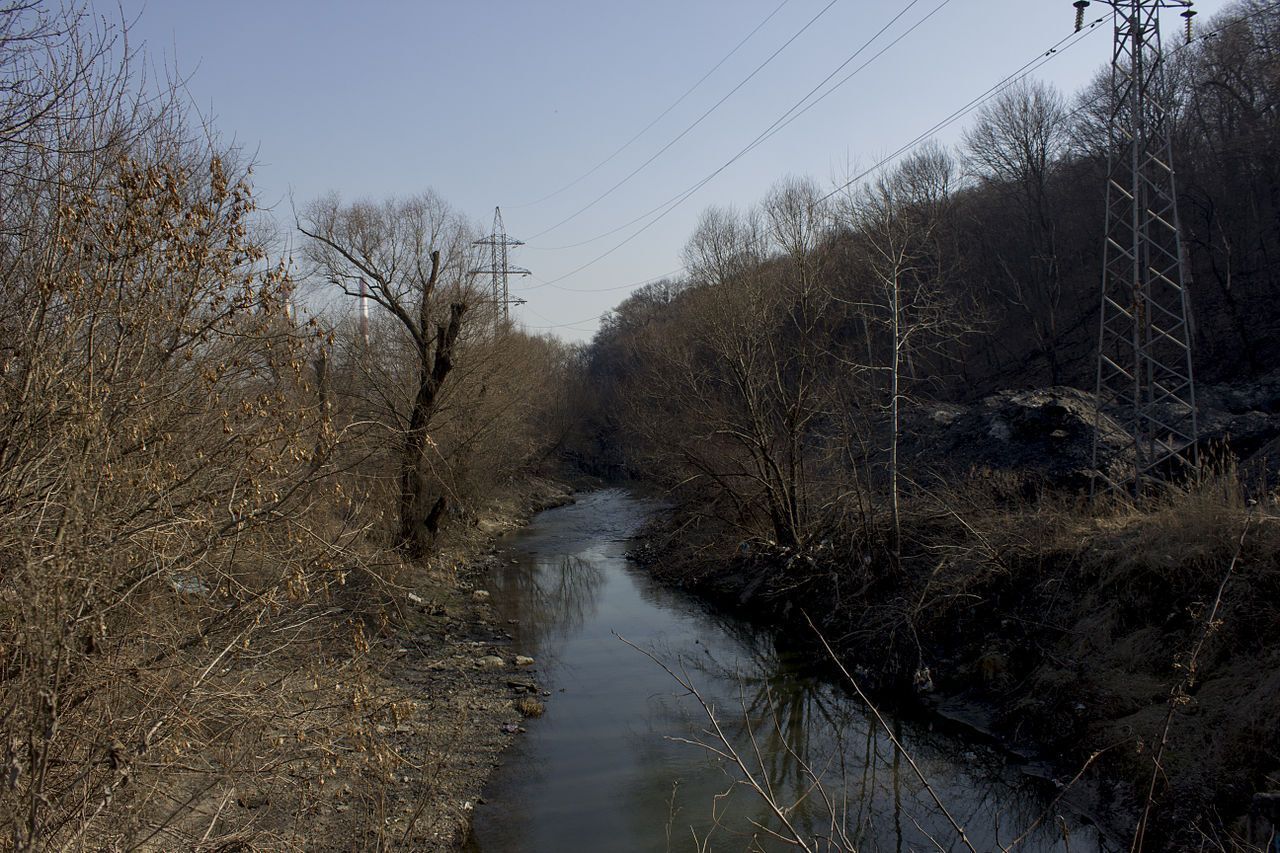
[1074,0,1198,496]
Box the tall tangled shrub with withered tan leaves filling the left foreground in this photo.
[0,4,419,850]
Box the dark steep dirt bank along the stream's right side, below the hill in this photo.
[636,493,1280,850]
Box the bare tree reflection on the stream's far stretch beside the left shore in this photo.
[488,556,604,653]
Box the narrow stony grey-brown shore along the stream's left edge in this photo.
[350,473,572,852]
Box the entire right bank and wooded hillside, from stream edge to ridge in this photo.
[570,0,1280,849]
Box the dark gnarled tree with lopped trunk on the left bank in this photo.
[298,191,476,560]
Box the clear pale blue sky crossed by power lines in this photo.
[92,0,1228,341]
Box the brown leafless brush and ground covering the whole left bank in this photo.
[0,3,568,850]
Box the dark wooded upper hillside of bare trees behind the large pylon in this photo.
[593,1,1280,450]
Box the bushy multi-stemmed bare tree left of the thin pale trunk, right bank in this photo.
[631,181,829,548]
